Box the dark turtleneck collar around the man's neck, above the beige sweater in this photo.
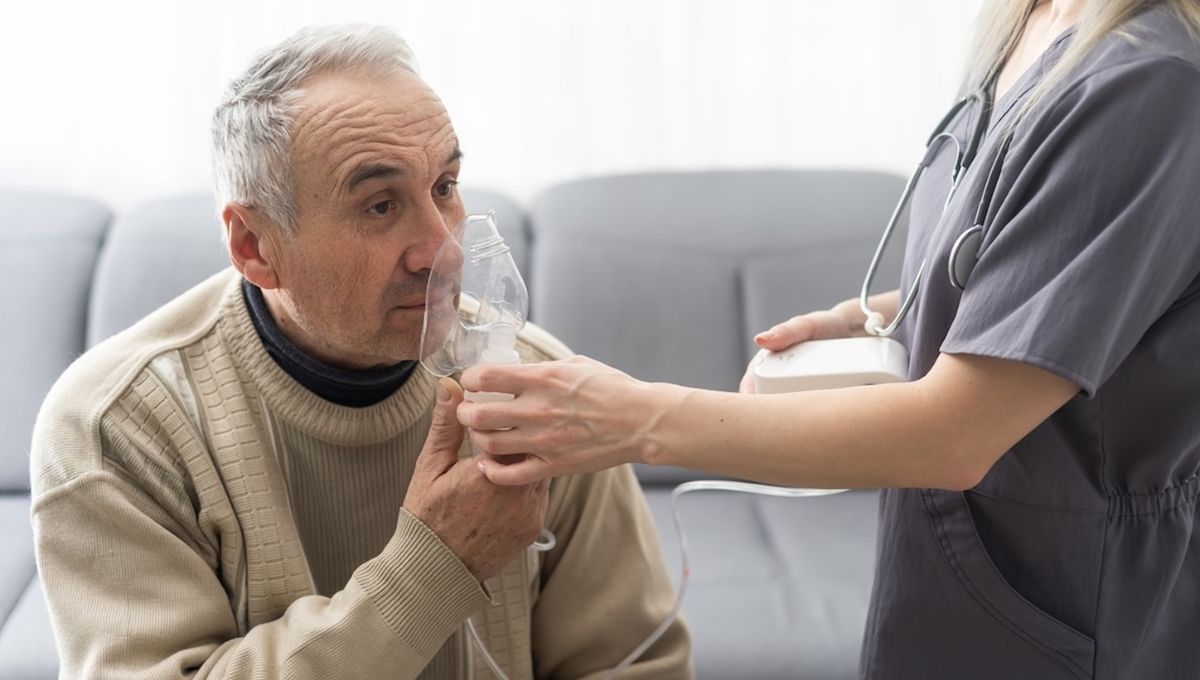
[241,279,416,408]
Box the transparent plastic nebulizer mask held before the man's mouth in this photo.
[421,212,529,377]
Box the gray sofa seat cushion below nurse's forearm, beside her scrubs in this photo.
[646,488,878,680]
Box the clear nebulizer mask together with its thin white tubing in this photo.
[421,212,845,680]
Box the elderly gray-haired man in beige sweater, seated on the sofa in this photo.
[32,28,691,680]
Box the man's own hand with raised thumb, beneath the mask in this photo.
[404,379,550,580]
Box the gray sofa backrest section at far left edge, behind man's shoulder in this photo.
[0,191,112,493]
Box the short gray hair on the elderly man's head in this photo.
[212,24,416,231]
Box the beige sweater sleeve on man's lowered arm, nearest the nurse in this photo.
[533,465,694,680]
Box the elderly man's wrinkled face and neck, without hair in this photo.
[266,73,464,369]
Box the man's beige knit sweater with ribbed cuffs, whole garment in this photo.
[32,270,691,680]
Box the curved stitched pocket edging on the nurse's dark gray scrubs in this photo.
[920,489,1096,680]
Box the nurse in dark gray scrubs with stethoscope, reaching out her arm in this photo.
[458,0,1200,680]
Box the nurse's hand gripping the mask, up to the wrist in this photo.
[458,356,683,485]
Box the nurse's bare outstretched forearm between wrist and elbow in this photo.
[647,385,973,488]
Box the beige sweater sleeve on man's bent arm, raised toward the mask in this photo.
[32,460,488,680]
